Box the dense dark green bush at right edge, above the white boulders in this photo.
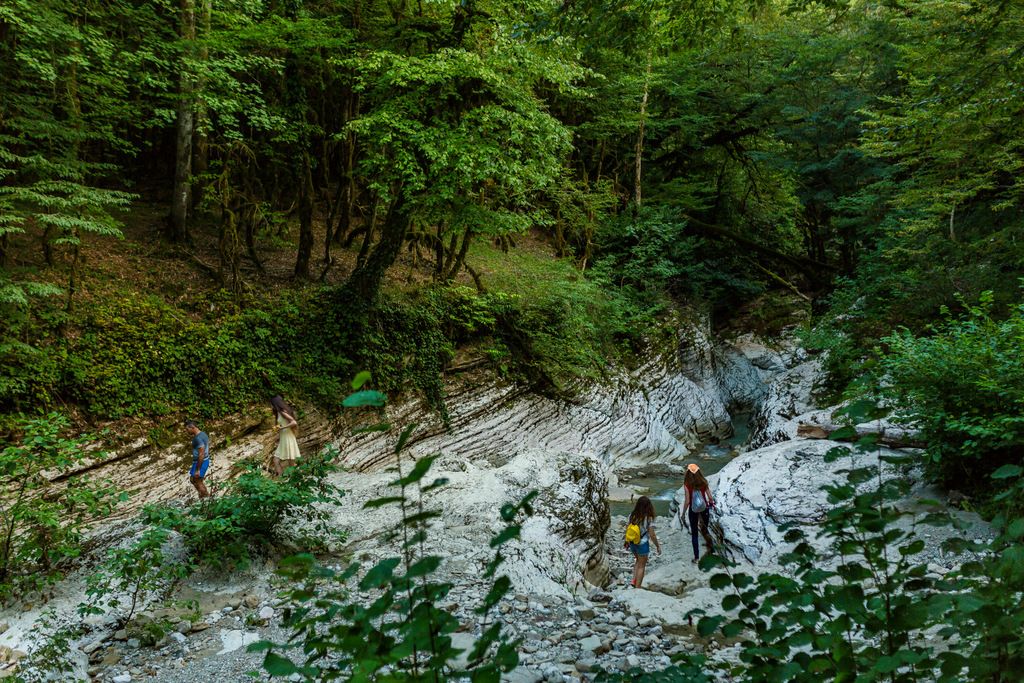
[881,292,1024,497]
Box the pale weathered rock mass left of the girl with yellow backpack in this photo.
[321,451,609,595]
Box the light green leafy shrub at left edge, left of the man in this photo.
[0,413,126,600]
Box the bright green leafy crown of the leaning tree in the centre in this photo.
[350,31,574,232]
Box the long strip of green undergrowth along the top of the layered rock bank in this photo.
[6,266,671,418]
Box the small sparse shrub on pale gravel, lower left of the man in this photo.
[79,527,193,622]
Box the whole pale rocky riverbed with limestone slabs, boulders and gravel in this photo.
[0,327,987,683]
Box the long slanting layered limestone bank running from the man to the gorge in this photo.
[74,317,753,517]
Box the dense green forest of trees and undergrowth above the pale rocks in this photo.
[0,0,1024,481]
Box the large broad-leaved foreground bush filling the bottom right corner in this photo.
[697,402,1024,683]
